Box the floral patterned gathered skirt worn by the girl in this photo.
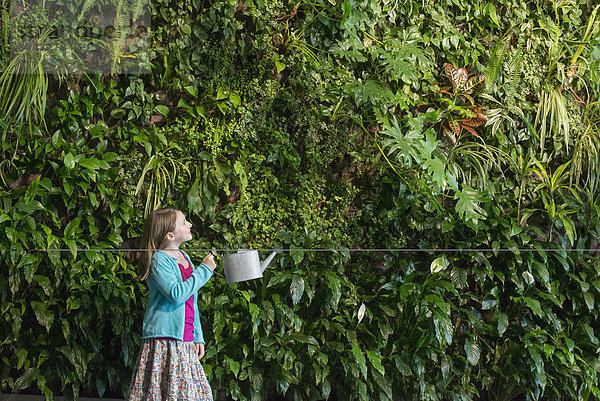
[127,338,213,401]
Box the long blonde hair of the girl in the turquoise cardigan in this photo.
[139,208,178,280]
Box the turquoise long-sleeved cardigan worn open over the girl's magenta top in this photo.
[142,251,213,343]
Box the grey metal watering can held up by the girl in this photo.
[220,249,281,284]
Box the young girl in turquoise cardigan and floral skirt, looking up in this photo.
[127,209,215,401]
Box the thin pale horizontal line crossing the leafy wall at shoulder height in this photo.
[16,248,600,253]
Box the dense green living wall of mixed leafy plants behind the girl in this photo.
[0,0,600,400]
